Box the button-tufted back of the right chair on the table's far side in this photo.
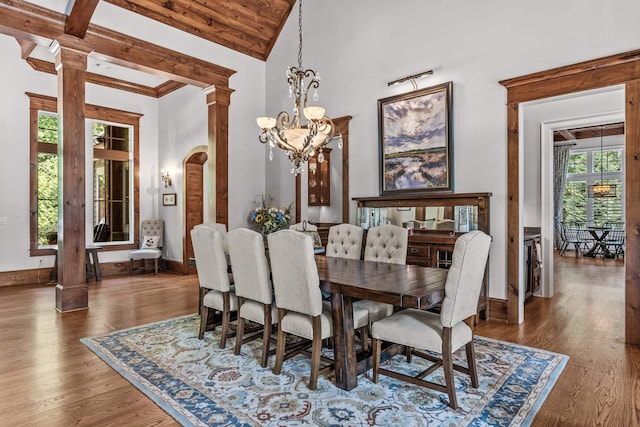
[364,224,409,264]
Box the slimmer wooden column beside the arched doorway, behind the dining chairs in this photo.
[206,86,233,226]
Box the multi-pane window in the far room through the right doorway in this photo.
[563,147,624,225]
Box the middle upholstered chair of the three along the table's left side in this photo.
[228,228,278,368]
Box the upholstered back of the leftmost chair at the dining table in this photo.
[191,227,231,292]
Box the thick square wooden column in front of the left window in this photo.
[51,41,89,312]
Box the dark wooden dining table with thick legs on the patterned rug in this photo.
[315,255,448,390]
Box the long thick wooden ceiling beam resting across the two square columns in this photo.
[0,0,235,88]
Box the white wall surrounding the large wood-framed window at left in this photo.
[0,35,158,271]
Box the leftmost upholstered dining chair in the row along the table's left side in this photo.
[191,227,238,348]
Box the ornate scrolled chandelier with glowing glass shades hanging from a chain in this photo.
[256,0,342,175]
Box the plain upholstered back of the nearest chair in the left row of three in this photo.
[267,230,322,316]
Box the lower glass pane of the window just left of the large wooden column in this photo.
[38,153,58,245]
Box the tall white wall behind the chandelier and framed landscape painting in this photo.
[266,0,640,298]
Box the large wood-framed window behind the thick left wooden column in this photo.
[28,94,140,255]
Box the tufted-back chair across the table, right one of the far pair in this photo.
[353,224,409,332]
